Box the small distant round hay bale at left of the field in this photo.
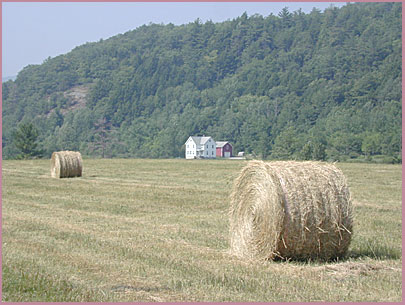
[51,151,83,178]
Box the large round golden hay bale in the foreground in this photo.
[230,161,352,260]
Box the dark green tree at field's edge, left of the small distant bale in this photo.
[13,123,42,159]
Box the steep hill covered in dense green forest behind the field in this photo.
[2,3,402,161]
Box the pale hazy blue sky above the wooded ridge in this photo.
[2,1,346,78]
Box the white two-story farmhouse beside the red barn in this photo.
[184,136,216,159]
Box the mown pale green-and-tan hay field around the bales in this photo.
[2,159,402,302]
